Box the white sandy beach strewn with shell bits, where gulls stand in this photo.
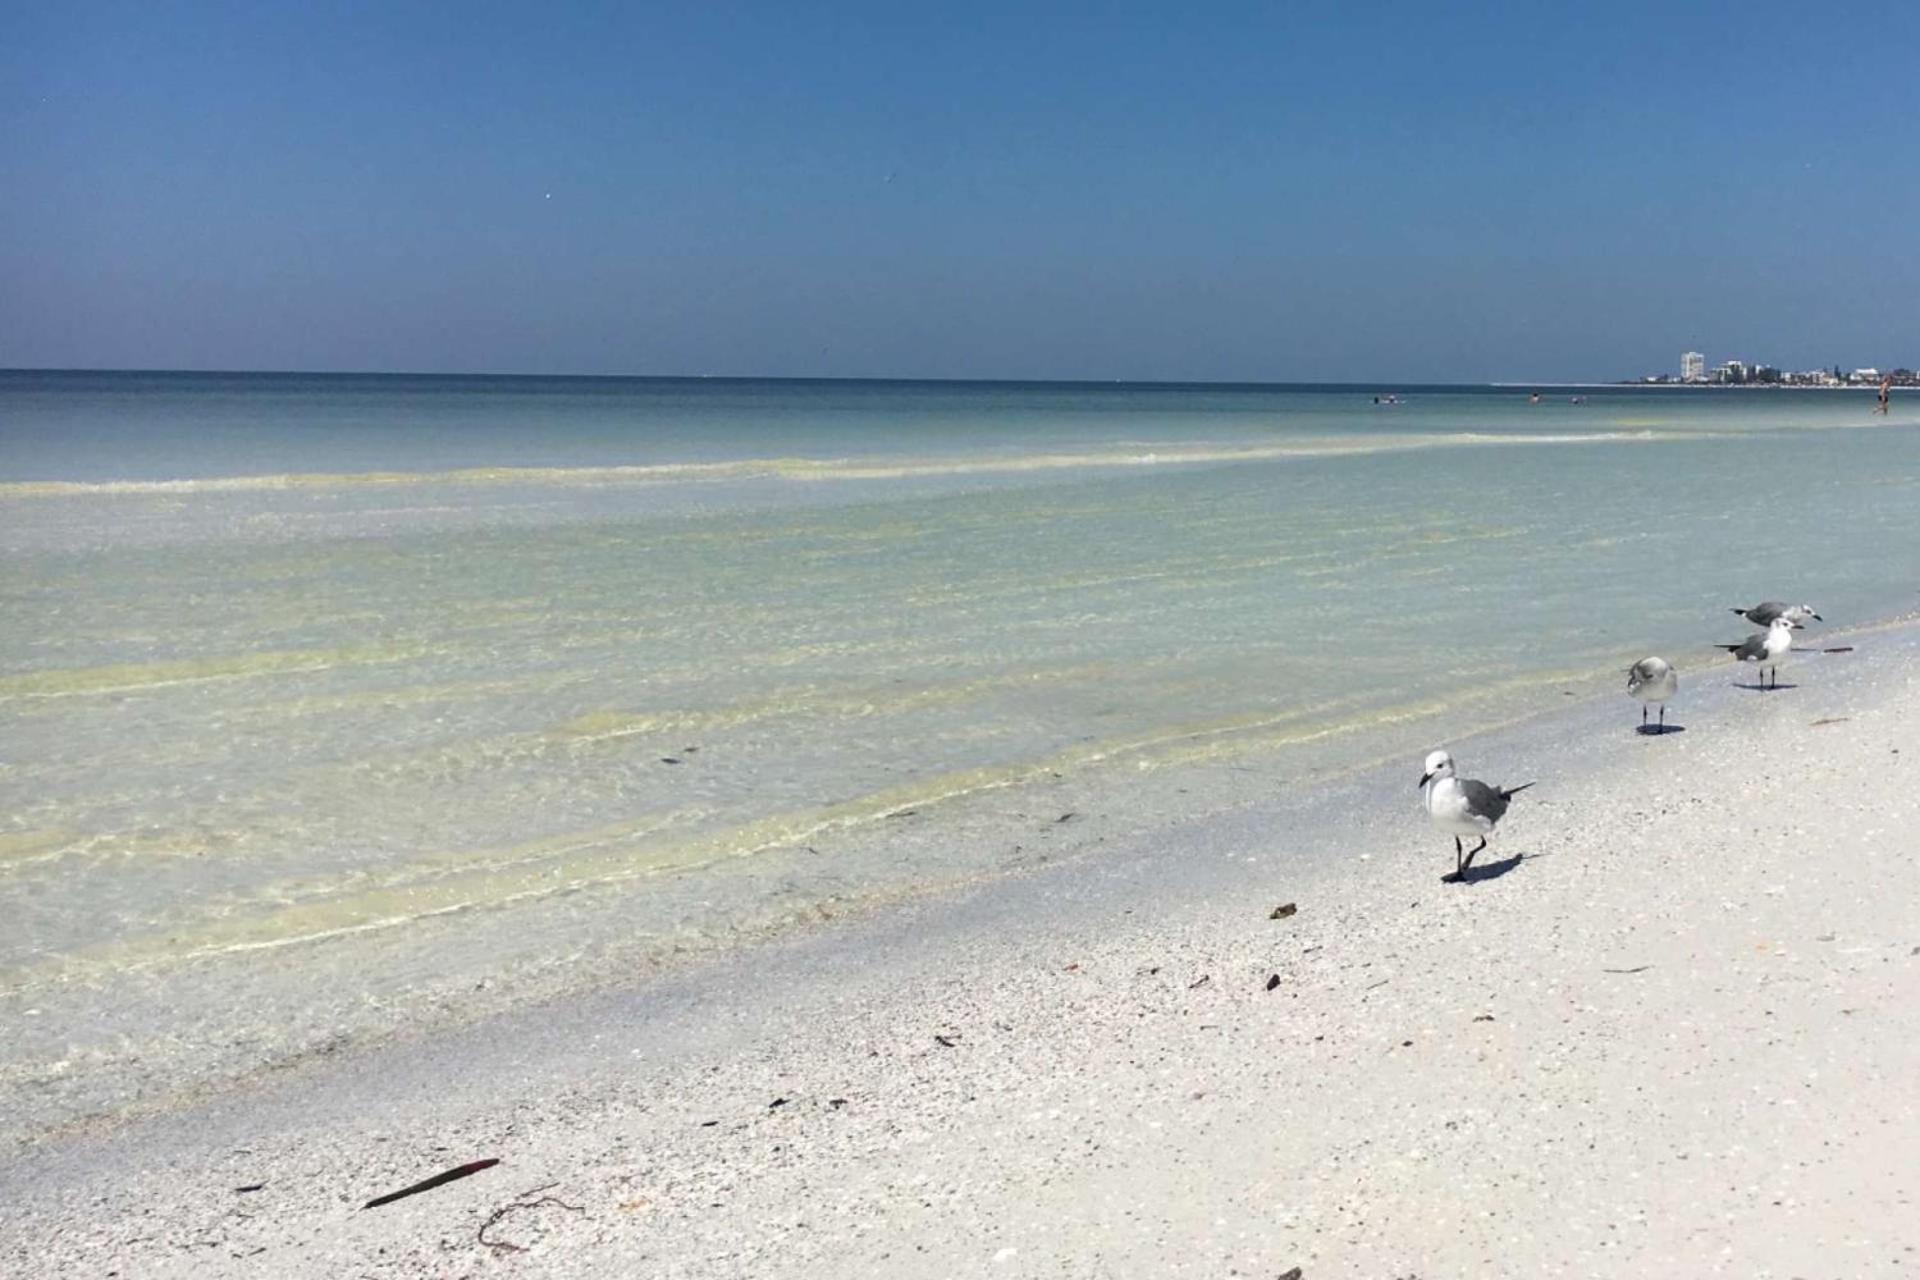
[0,626,1920,1280]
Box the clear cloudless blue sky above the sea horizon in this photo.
[0,0,1920,380]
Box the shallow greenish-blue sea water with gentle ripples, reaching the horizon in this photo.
[0,372,1920,1136]
